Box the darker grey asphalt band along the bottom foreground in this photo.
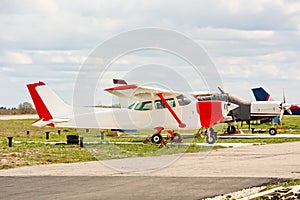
[0,176,276,200]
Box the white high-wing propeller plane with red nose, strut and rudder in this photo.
[27,80,238,144]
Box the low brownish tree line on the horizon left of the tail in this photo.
[0,102,36,115]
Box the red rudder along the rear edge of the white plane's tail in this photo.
[27,82,53,121]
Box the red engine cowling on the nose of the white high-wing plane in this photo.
[197,101,224,128]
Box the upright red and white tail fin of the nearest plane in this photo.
[27,82,72,125]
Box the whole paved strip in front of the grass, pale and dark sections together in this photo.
[0,142,300,199]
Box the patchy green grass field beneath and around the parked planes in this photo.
[0,116,300,169]
